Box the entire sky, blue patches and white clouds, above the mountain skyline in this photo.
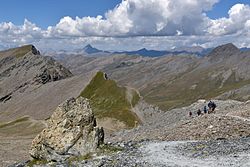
[0,0,250,50]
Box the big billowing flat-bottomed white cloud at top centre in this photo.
[49,0,218,36]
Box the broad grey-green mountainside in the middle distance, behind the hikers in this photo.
[56,44,250,110]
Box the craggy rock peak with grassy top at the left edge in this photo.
[0,45,72,103]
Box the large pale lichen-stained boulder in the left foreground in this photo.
[30,97,104,161]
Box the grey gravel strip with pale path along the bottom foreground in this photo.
[11,137,250,167]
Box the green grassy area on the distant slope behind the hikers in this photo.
[142,69,250,110]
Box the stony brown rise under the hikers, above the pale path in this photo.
[107,100,250,144]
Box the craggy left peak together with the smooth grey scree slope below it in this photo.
[0,45,94,122]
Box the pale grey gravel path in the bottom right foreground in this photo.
[141,142,250,167]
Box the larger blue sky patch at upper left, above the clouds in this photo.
[0,0,121,28]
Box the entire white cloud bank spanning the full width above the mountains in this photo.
[0,0,250,50]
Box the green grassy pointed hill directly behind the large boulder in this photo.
[80,72,140,128]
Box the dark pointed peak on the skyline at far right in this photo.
[208,43,240,58]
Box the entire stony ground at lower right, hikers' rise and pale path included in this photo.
[11,100,250,167]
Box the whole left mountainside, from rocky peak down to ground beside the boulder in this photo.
[0,45,95,167]
